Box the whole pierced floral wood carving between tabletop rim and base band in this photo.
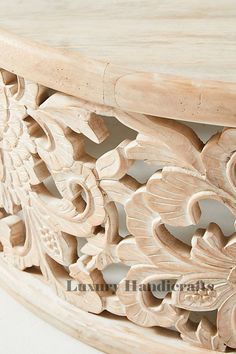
[0,70,236,351]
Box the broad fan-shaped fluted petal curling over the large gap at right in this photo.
[147,167,234,226]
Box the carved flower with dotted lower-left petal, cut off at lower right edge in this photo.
[172,230,236,348]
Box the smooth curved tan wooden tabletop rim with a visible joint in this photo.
[0,30,236,127]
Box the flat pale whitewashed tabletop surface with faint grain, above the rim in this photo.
[0,0,236,82]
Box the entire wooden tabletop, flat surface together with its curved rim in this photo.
[0,0,236,126]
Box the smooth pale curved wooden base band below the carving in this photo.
[0,257,224,354]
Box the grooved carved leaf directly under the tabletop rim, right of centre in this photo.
[116,113,204,172]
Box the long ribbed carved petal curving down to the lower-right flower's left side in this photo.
[125,187,192,274]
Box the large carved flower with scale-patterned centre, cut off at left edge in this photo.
[0,70,107,312]
